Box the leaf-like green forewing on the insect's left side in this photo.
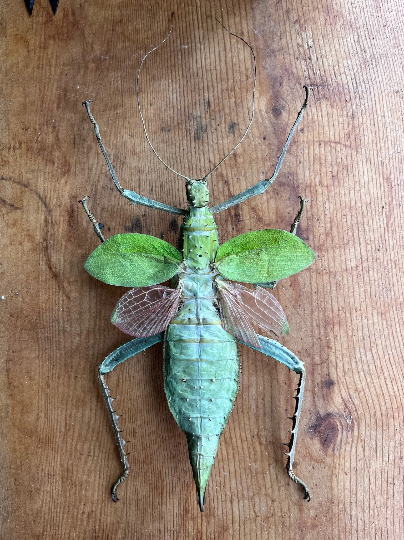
[84,233,182,287]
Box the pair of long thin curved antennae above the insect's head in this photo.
[136,19,257,180]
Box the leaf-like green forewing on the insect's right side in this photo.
[215,229,316,283]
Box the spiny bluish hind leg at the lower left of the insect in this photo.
[98,332,164,502]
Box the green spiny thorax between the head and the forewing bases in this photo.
[181,206,219,273]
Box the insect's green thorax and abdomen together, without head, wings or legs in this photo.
[164,207,240,505]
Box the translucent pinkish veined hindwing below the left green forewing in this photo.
[111,285,181,337]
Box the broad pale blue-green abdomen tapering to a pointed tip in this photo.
[164,299,240,508]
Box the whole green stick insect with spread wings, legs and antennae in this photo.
[80,27,315,511]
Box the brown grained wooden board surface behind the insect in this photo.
[0,0,404,540]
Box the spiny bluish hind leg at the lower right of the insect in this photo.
[241,336,310,501]
